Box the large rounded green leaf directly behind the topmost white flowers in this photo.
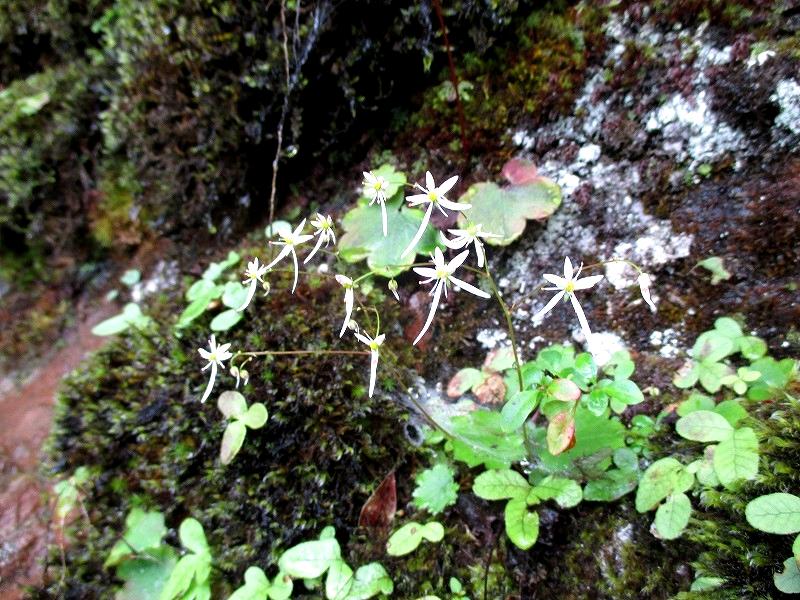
[339,194,438,277]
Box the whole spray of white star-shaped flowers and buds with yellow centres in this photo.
[199,166,655,402]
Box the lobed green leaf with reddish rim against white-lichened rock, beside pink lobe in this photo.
[458,178,561,246]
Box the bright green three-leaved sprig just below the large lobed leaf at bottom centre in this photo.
[472,469,583,550]
